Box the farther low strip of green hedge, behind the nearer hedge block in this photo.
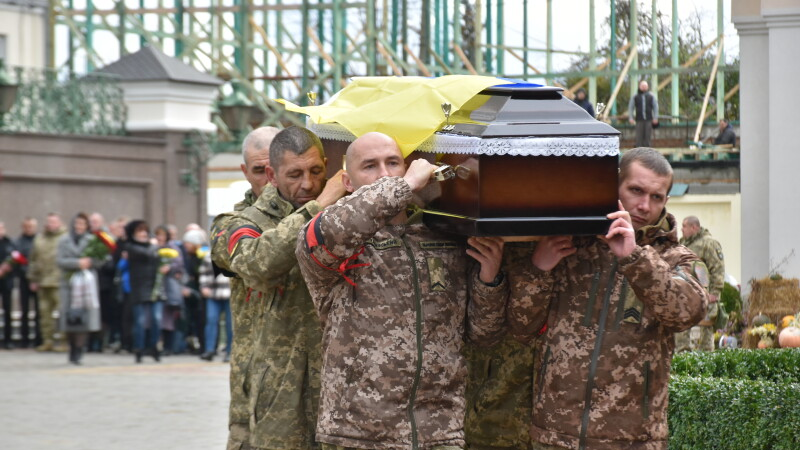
[672,348,800,384]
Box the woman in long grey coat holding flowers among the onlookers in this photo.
[56,213,103,364]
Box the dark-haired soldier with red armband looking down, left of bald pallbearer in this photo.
[215,127,344,450]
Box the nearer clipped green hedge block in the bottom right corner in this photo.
[669,374,800,450]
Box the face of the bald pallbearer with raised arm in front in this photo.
[342,136,406,192]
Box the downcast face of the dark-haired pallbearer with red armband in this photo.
[267,146,325,208]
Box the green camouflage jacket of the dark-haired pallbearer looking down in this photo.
[217,186,322,450]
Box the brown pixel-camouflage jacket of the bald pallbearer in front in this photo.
[297,177,507,449]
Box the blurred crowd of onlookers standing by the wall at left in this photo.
[0,212,233,364]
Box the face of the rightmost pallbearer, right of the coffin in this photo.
[619,162,671,230]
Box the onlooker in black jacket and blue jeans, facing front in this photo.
[124,220,162,363]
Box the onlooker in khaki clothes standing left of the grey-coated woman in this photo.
[28,213,66,352]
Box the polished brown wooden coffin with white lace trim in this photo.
[309,85,619,236]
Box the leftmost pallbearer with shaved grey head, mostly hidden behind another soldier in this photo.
[211,127,280,450]
